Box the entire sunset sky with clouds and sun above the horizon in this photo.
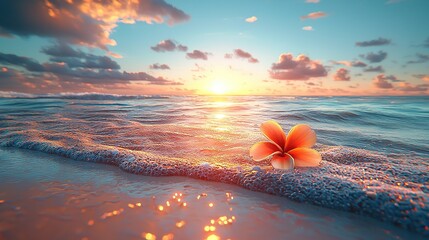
[0,0,429,96]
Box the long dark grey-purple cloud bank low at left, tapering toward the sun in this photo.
[0,48,182,91]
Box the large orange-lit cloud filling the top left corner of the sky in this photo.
[0,0,190,50]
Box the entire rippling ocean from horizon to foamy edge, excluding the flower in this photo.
[0,94,429,234]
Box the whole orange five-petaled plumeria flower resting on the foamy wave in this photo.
[250,120,322,169]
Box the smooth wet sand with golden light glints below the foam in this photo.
[0,148,423,240]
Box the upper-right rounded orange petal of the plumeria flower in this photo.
[285,124,316,152]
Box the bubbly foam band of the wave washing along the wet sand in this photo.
[1,136,429,235]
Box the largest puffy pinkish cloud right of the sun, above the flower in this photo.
[270,53,327,80]
